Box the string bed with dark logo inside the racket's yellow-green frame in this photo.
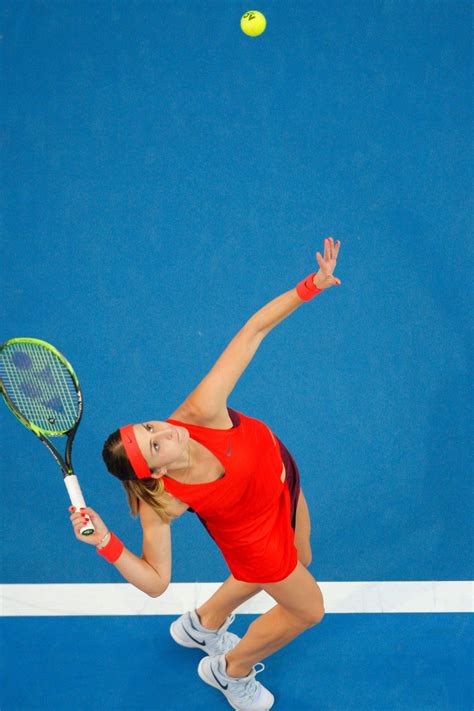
[0,342,79,433]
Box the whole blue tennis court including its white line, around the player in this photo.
[0,0,474,711]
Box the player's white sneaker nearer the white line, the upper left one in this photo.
[170,610,240,656]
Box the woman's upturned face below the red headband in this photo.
[133,420,189,478]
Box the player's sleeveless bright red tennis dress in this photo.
[163,408,299,583]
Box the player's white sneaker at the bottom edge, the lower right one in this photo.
[198,654,275,711]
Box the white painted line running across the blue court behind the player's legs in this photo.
[0,580,474,617]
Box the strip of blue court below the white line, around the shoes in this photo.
[2,614,473,711]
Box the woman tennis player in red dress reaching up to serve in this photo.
[71,237,341,711]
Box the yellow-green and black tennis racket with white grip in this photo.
[0,338,95,536]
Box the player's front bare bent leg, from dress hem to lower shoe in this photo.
[225,561,324,677]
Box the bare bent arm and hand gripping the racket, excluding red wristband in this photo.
[71,502,171,597]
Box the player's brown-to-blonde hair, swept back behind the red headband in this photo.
[102,430,174,523]
